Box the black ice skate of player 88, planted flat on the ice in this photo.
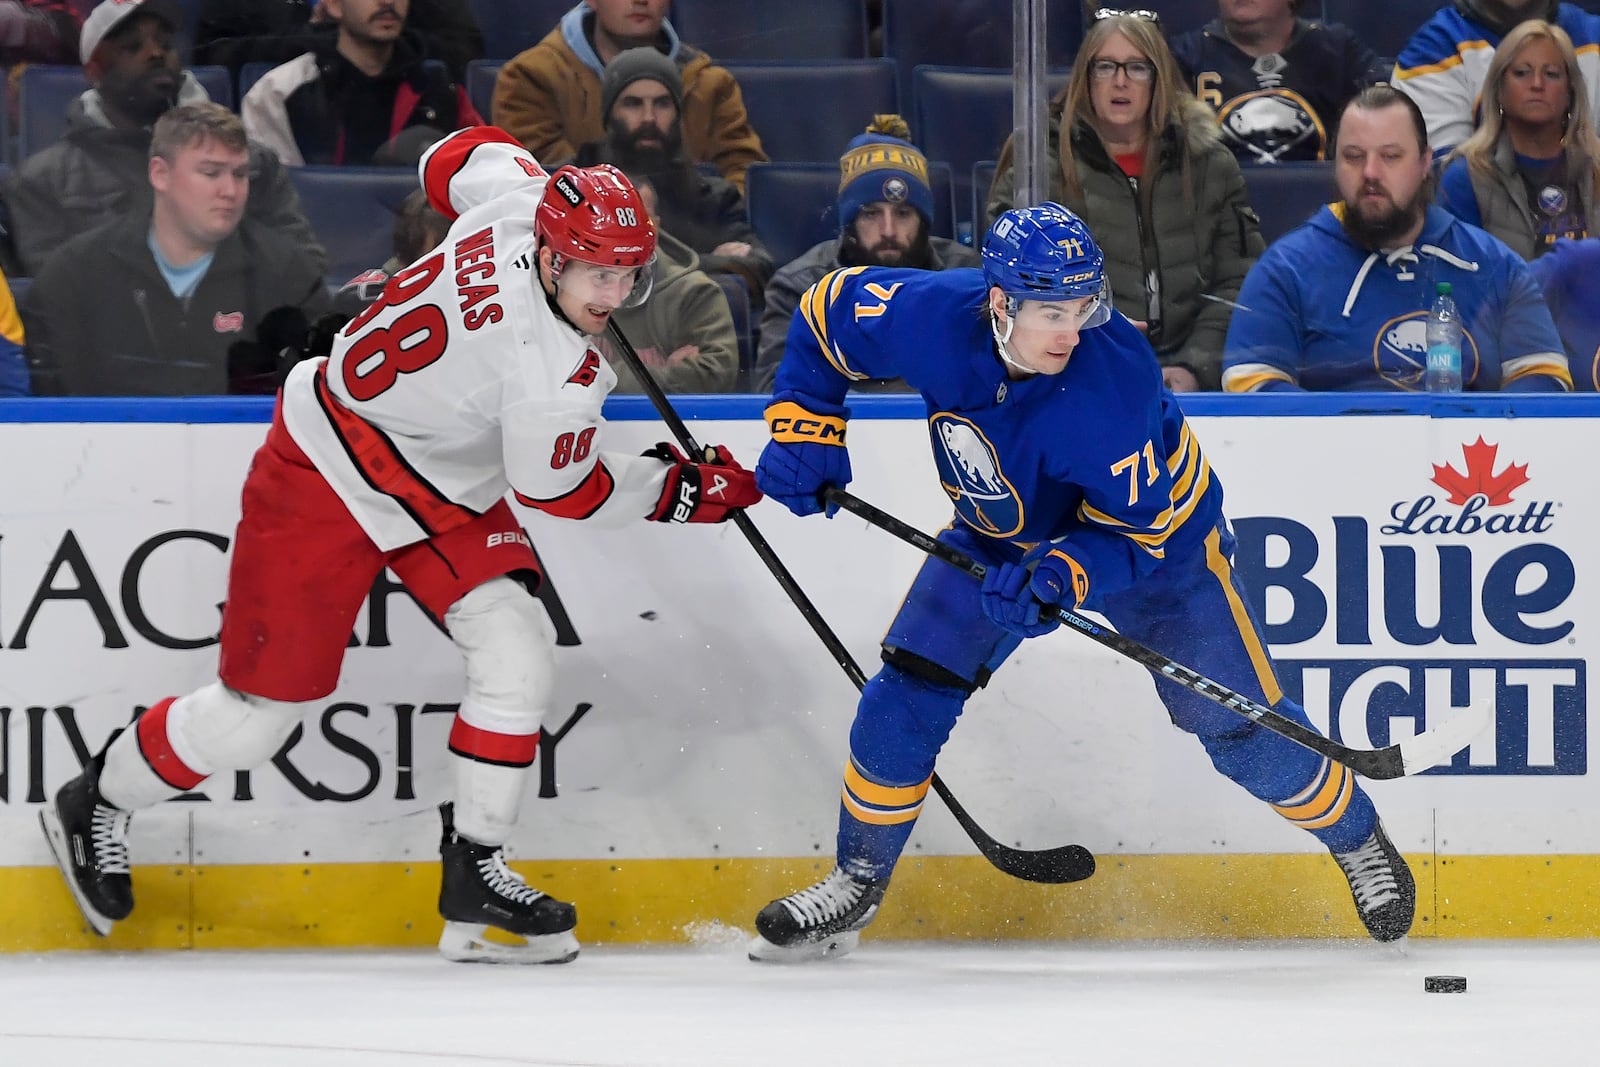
[438,803,578,963]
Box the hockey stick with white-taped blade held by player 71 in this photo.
[822,486,1494,779]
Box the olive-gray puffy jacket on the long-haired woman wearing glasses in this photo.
[987,94,1266,389]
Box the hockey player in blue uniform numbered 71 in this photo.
[750,203,1416,960]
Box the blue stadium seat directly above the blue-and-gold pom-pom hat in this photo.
[726,59,899,163]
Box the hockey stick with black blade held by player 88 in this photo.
[610,320,1094,885]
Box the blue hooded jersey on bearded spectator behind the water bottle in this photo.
[1222,205,1573,392]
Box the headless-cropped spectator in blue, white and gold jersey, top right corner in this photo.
[1392,0,1600,155]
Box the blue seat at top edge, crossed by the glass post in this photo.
[883,0,1088,99]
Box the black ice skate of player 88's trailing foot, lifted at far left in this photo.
[38,753,133,937]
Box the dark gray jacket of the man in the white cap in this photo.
[5,70,328,275]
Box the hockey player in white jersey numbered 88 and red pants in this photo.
[40,126,760,963]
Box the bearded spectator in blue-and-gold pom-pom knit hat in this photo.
[754,115,981,392]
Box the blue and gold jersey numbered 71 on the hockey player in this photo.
[774,267,1222,607]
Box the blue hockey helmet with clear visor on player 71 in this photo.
[982,202,1110,330]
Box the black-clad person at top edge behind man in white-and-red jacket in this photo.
[195,0,480,82]
